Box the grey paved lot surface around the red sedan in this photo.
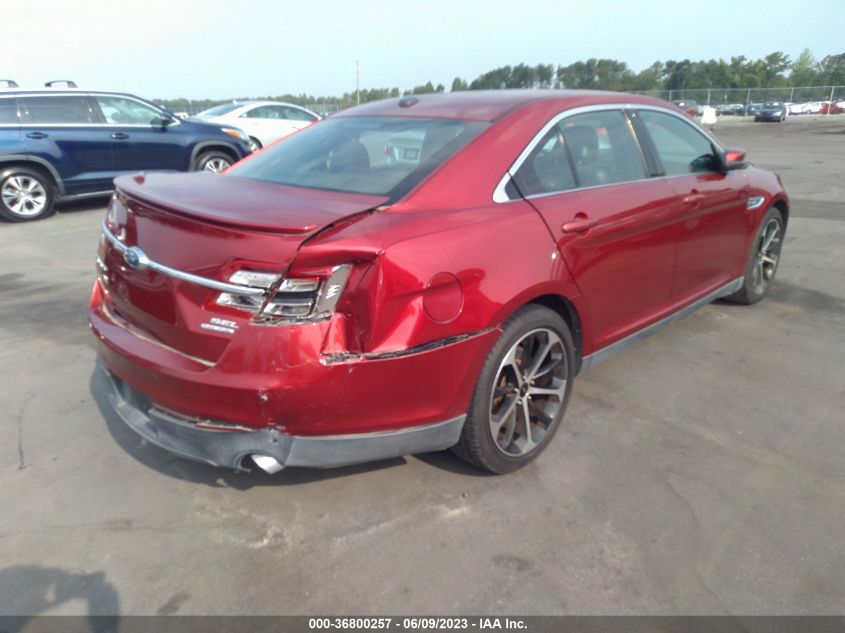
[0,116,845,615]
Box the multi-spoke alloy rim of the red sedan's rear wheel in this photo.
[490,328,569,457]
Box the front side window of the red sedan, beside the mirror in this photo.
[639,110,719,176]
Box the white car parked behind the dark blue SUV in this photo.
[196,101,320,151]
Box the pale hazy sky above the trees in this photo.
[6,0,845,98]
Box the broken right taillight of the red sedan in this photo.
[217,264,352,324]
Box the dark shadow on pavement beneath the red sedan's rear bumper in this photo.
[89,369,486,490]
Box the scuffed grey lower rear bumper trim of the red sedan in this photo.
[93,363,466,470]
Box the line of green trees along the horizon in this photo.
[156,48,845,112]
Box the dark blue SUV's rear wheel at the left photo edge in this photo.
[0,166,56,222]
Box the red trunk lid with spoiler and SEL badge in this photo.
[100,173,386,362]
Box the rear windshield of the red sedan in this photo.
[229,117,489,200]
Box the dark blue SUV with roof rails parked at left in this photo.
[0,89,250,221]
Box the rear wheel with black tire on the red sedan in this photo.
[452,304,575,475]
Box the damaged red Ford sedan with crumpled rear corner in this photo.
[88,91,789,473]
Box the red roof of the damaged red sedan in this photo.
[332,90,673,121]
